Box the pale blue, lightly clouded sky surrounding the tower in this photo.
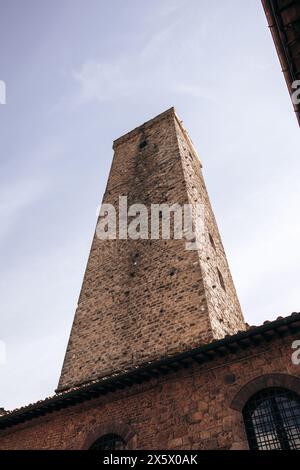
[0,0,300,409]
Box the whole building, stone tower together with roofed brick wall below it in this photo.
[0,108,300,450]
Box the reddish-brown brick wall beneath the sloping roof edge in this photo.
[0,337,300,449]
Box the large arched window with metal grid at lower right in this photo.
[243,387,300,450]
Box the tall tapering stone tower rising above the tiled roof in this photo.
[58,108,245,391]
